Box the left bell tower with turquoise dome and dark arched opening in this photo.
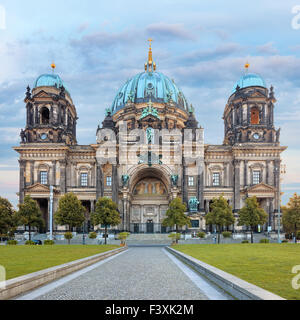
[20,63,78,145]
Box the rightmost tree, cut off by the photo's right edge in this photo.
[282,193,300,243]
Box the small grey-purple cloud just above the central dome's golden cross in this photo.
[146,22,196,40]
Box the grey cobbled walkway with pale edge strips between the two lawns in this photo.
[19,247,228,300]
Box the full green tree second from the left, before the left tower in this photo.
[17,195,45,240]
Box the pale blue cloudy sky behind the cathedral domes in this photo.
[0,0,300,205]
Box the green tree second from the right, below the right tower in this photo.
[238,197,268,243]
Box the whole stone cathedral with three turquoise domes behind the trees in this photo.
[14,42,286,233]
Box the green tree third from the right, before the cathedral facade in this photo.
[205,196,234,243]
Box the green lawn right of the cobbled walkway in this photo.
[174,243,300,300]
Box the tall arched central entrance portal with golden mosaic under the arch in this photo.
[129,168,169,233]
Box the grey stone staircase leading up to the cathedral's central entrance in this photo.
[126,233,172,246]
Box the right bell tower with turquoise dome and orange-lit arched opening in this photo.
[223,63,280,145]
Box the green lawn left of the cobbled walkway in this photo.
[0,245,118,279]
